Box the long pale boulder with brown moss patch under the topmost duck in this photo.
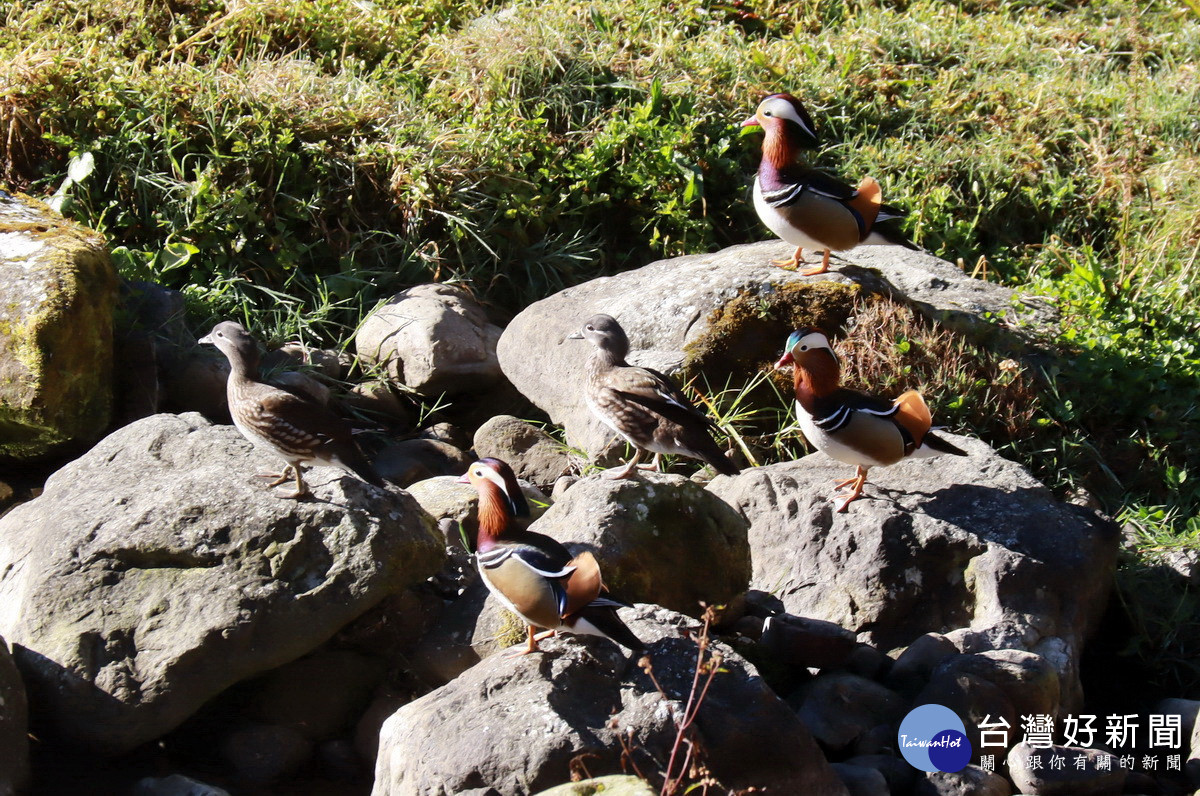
[497,241,1052,455]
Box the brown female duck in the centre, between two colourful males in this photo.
[569,315,739,479]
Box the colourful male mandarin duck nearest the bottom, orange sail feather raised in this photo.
[458,459,646,654]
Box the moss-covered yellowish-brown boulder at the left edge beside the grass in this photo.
[0,191,116,461]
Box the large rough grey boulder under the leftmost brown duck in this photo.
[0,414,445,754]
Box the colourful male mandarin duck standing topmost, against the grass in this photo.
[742,94,916,276]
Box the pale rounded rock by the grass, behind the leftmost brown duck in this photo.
[354,285,502,396]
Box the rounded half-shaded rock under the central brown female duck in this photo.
[529,474,750,615]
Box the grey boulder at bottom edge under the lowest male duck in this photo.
[373,605,846,796]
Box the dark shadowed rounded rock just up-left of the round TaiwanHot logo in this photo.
[797,672,908,749]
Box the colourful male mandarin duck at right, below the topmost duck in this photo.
[775,329,967,511]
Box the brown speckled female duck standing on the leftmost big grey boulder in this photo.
[199,321,384,498]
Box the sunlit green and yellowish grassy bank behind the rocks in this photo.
[0,0,1200,687]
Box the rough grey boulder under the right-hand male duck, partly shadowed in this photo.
[705,435,1118,710]
